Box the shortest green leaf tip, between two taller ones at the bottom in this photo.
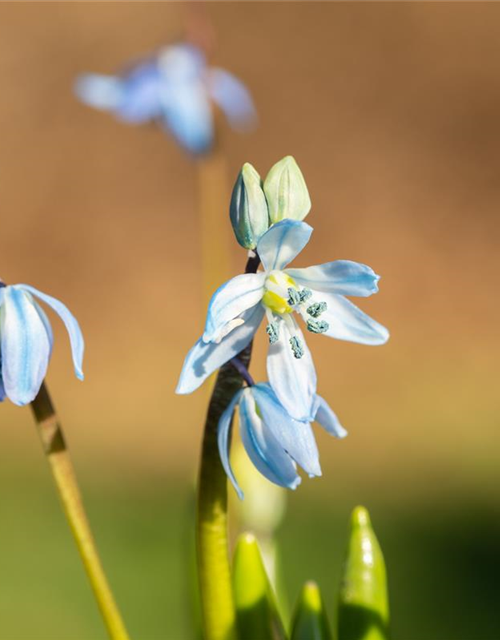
[292,582,332,640]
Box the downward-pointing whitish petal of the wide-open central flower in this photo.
[267,321,317,422]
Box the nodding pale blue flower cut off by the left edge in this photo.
[0,283,84,406]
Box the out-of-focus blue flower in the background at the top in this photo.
[75,44,256,154]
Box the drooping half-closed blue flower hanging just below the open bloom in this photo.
[218,383,347,498]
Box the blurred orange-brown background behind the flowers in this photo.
[0,1,500,640]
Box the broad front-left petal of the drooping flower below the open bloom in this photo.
[240,389,300,489]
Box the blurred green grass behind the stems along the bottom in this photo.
[0,467,500,640]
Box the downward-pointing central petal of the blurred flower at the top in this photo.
[163,80,214,154]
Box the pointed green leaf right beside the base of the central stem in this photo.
[233,533,286,640]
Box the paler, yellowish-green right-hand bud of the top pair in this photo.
[264,156,311,224]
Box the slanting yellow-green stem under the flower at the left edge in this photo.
[31,384,129,640]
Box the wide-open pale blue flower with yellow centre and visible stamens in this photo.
[177,220,389,421]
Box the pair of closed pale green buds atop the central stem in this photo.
[229,156,311,249]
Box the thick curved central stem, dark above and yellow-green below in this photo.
[197,254,260,640]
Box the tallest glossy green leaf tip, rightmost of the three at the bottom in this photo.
[338,507,389,640]
